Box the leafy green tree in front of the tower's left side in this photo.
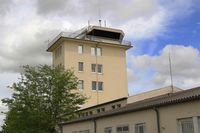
[2,65,86,133]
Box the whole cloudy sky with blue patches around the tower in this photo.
[0,0,200,129]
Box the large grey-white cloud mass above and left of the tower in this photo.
[0,0,198,72]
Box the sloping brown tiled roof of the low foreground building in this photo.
[60,87,200,125]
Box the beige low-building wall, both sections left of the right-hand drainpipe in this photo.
[63,110,157,133]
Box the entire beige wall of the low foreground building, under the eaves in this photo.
[63,101,200,133]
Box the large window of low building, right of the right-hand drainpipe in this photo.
[178,118,194,133]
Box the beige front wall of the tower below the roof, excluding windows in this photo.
[63,41,128,107]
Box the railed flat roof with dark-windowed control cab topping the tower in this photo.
[47,26,132,52]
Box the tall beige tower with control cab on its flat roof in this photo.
[47,26,132,108]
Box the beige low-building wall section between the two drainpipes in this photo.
[97,110,156,133]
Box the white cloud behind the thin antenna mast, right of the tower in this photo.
[129,45,200,89]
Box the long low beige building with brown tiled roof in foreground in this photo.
[60,87,200,133]
